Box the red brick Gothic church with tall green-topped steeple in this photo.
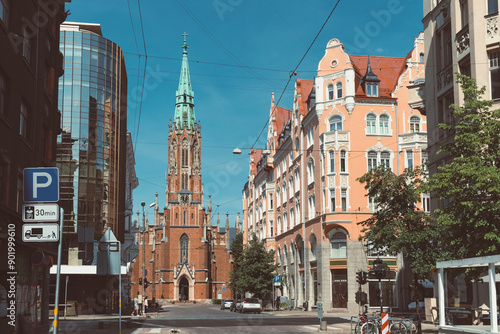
[131,35,239,301]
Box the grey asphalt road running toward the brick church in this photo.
[55,304,350,334]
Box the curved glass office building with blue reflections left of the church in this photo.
[57,22,127,265]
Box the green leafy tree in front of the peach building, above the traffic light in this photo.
[358,166,438,279]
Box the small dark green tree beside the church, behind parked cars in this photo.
[243,234,276,299]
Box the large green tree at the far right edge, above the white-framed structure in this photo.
[429,73,500,259]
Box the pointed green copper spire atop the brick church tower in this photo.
[174,33,196,129]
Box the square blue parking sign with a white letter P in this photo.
[23,167,59,203]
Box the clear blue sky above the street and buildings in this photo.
[66,0,423,225]
